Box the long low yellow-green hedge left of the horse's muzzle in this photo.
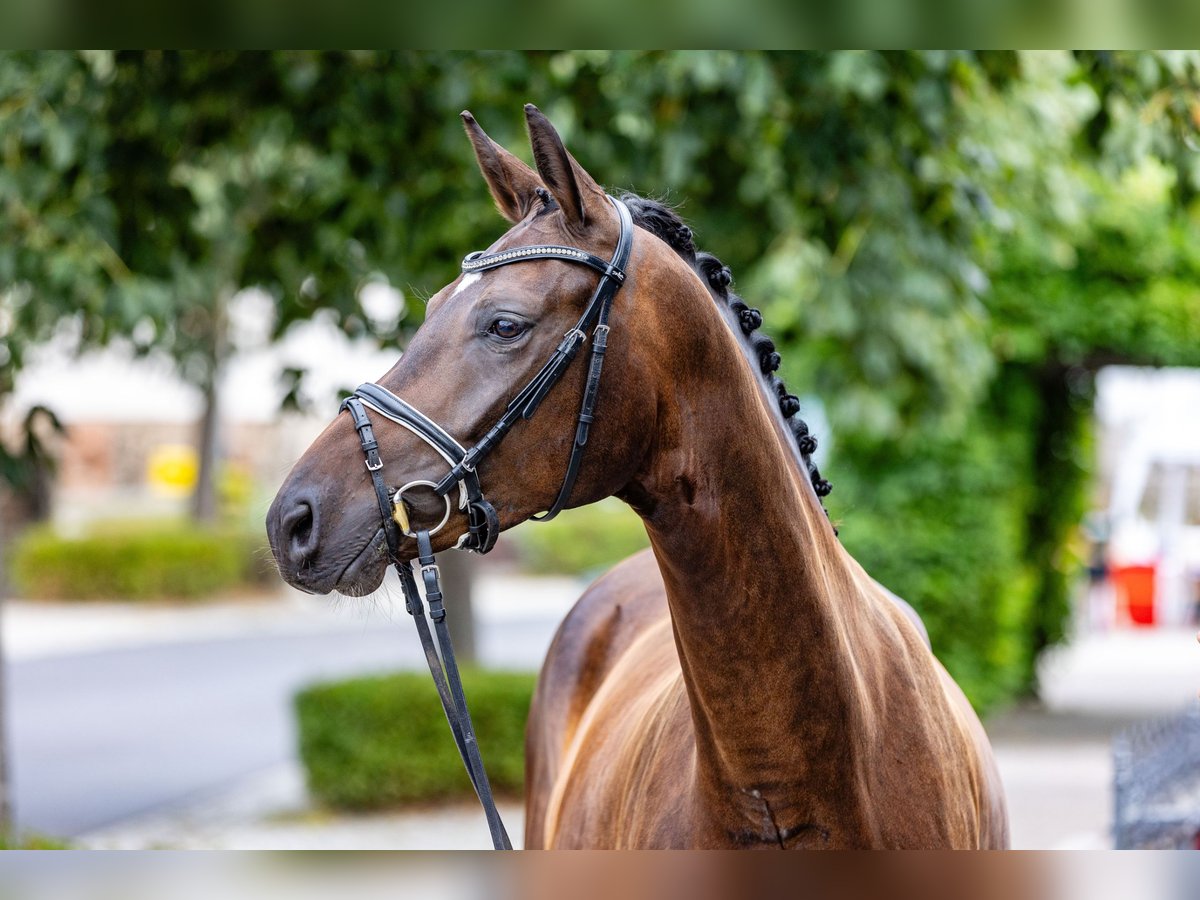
[11,522,273,600]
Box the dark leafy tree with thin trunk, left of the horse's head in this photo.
[88,53,405,520]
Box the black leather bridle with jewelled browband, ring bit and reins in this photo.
[340,197,634,850]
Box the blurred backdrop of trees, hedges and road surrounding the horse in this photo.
[0,52,1200,848]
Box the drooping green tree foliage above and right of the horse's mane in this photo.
[518,52,1013,434]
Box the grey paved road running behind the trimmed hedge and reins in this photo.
[8,616,557,836]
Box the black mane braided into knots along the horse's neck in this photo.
[620,193,833,515]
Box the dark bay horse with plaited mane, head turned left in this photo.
[268,106,1008,848]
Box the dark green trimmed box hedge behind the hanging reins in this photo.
[295,670,536,811]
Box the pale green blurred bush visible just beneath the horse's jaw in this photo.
[512,498,649,577]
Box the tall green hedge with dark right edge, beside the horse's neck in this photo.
[830,365,1092,712]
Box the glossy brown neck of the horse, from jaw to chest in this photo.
[623,270,878,820]
